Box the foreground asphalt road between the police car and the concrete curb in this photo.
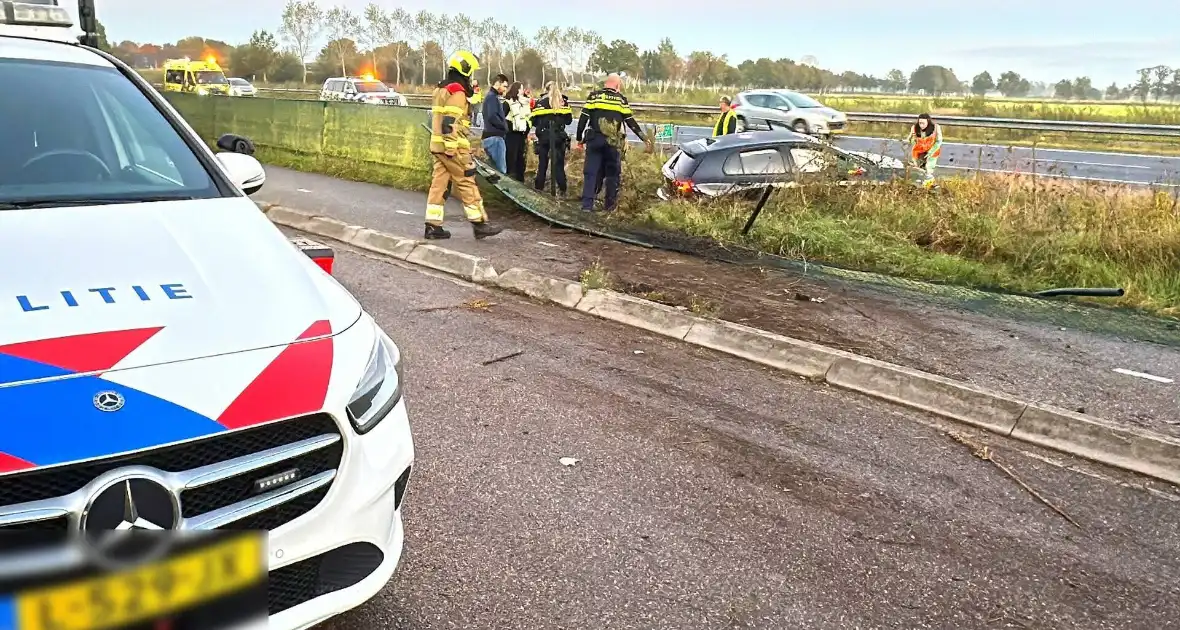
[309,245,1180,630]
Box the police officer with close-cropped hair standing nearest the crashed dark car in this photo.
[577,73,650,211]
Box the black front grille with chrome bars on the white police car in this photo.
[0,413,343,534]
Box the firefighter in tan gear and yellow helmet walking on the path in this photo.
[426,51,502,239]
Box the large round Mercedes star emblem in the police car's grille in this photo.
[78,473,181,570]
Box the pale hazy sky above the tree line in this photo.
[96,0,1180,86]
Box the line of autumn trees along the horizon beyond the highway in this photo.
[101,0,1180,101]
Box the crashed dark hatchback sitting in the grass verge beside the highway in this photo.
[657,130,926,199]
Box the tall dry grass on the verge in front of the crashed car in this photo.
[623,163,1180,316]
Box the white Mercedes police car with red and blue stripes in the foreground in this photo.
[0,0,414,629]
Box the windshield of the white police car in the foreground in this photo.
[0,56,222,208]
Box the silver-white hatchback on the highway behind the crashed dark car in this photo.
[734,90,848,137]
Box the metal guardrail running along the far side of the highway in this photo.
[202,87,1180,138]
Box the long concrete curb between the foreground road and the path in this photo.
[260,204,1180,485]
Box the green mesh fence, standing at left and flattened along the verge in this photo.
[159,93,1180,346]
